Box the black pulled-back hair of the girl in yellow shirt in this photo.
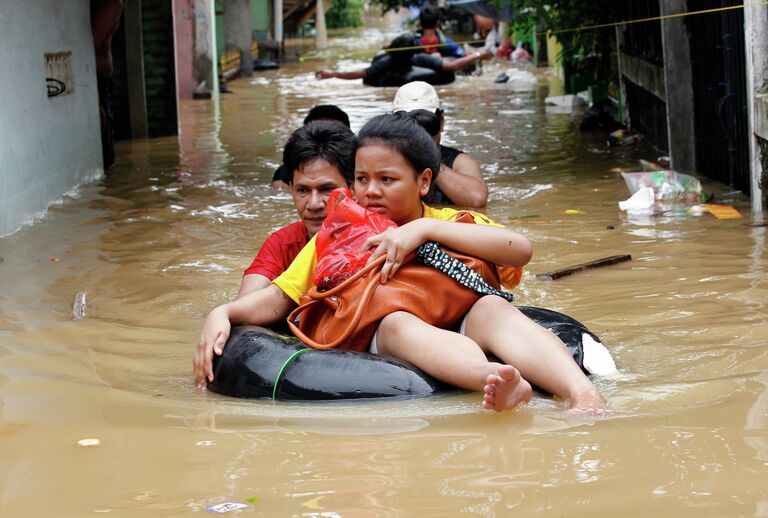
[357,114,440,197]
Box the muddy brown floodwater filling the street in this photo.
[0,16,768,517]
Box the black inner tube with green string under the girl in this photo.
[208,306,600,401]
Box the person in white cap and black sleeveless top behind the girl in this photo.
[392,81,488,209]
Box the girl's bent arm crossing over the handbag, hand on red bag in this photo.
[363,218,533,282]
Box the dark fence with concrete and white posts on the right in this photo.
[616,0,768,214]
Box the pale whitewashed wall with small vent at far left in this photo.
[0,0,103,236]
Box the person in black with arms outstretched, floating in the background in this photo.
[315,34,493,86]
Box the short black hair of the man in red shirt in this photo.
[283,120,356,185]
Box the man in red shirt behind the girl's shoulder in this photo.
[237,121,355,298]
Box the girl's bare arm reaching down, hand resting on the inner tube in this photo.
[192,284,296,388]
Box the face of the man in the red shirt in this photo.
[291,158,347,236]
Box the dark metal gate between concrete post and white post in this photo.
[686,0,750,195]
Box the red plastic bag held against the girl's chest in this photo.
[310,189,397,288]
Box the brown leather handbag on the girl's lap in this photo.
[288,249,499,351]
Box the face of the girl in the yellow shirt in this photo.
[354,144,432,225]
